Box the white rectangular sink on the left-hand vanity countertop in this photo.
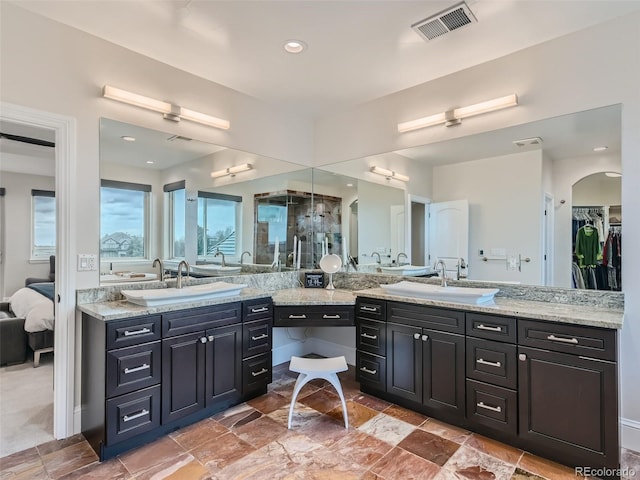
[120,282,247,307]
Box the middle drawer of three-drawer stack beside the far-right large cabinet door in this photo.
[466,337,518,388]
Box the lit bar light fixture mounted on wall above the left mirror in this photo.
[102,85,230,130]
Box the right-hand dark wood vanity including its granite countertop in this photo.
[356,289,622,476]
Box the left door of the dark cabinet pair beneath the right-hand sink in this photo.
[387,323,422,403]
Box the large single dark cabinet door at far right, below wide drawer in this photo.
[518,347,619,468]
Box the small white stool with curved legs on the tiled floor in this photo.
[289,356,349,429]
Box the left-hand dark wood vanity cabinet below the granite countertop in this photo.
[82,298,273,460]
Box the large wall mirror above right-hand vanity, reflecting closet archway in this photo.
[316,105,622,290]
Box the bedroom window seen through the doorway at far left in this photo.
[31,190,56,260]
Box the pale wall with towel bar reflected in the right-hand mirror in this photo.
[433,150,544,285]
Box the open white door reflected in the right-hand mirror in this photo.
[429,200,469,278]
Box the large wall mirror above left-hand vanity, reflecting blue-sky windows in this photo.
[100,118,315,283]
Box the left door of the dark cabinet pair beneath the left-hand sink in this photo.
[162,332,207,423]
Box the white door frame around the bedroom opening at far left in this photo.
[0,102,77,439]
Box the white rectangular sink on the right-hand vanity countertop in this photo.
[380,281,500,304]
